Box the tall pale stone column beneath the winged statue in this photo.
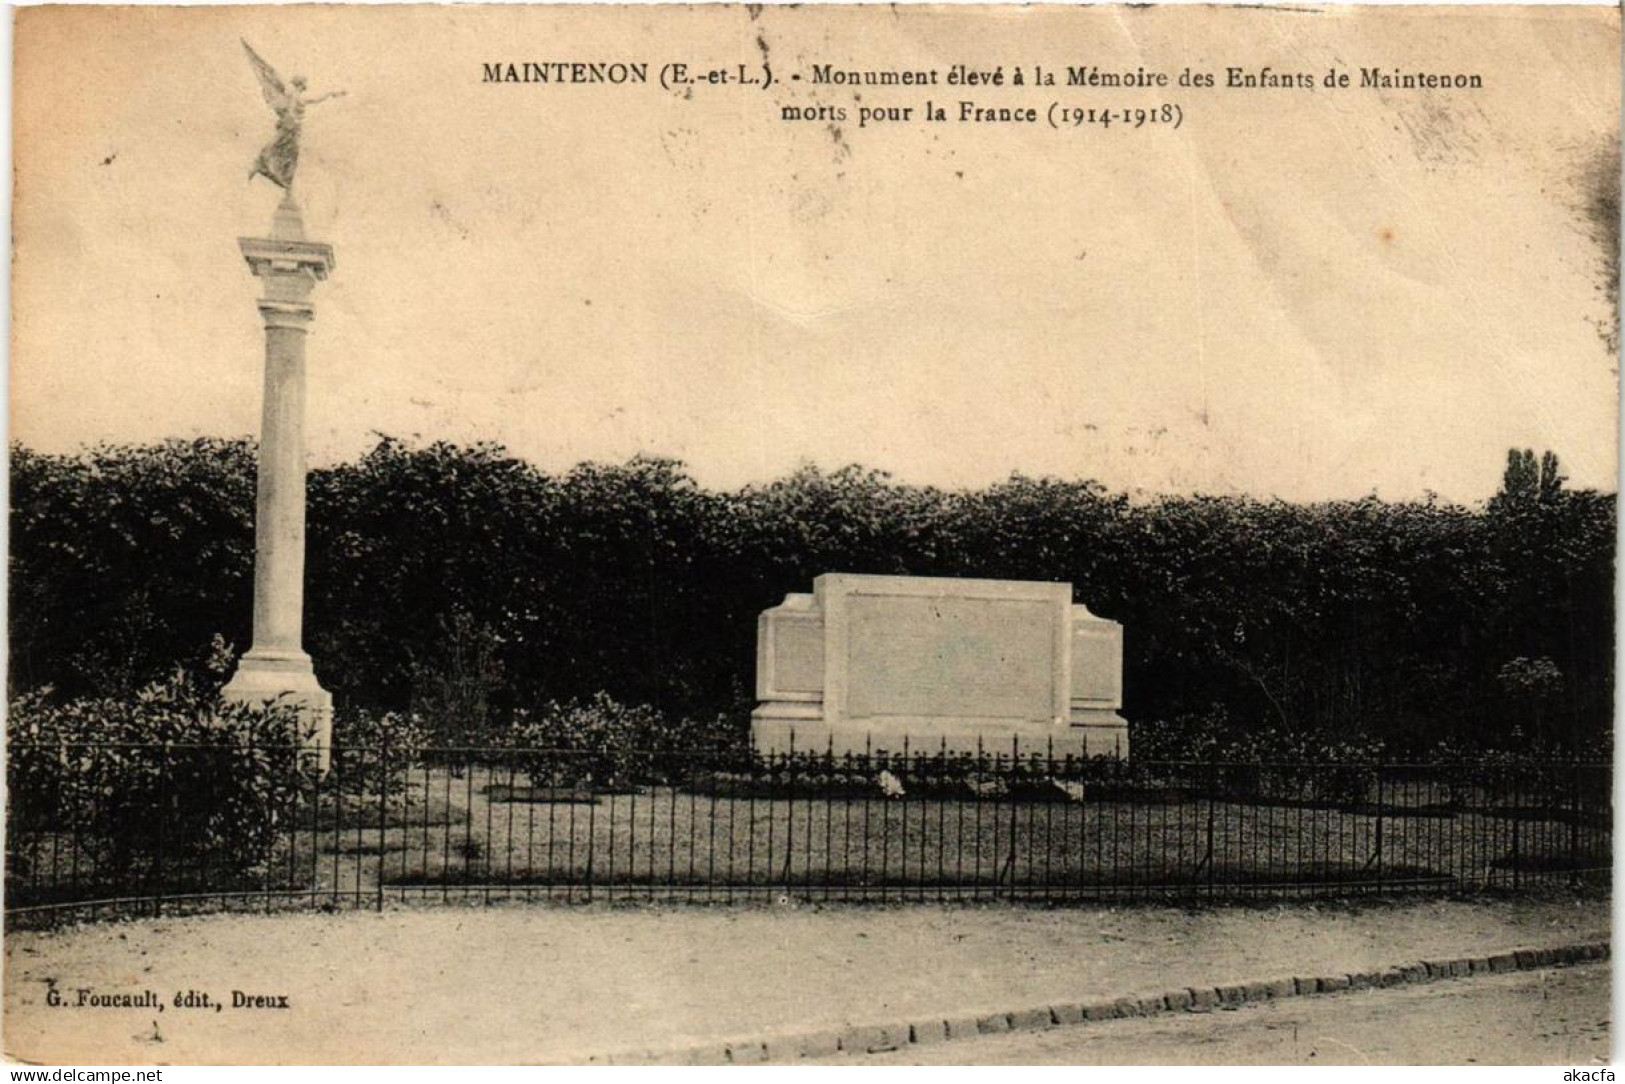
[221,197,333,770]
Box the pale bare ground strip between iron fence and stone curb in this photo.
[5,897,1609,1063]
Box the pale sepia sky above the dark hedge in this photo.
[11,8,1619,502]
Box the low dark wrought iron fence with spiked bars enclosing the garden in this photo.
[5,743,1612,923]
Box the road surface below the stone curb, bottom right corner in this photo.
[832,964,1609,1066]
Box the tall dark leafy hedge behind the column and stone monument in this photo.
[10,439,1615,751]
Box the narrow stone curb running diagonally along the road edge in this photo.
[587,941,1609,1064]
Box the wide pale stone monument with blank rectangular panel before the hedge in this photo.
[751,572,1128,757]
